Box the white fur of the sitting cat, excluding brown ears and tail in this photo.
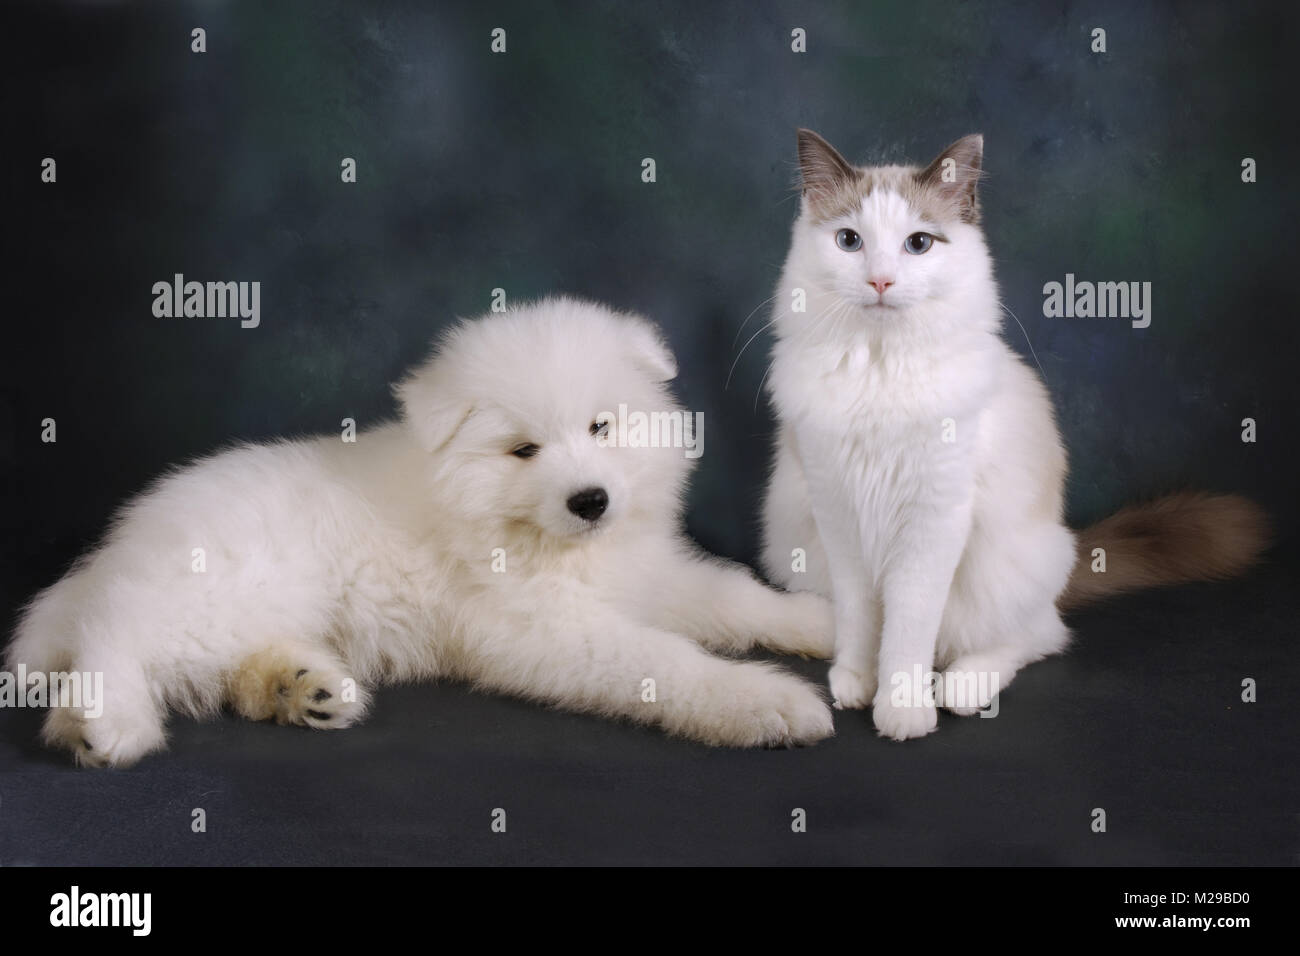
[763,175,1075,739]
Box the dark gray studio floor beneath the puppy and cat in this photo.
[0,548,1300,866]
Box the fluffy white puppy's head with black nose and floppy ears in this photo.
[397,298,690,544]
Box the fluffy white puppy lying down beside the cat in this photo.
[8,298,833,766]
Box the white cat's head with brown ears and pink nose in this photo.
[787,130,996,340]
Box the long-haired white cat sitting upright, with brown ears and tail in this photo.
[763,130,1266,740]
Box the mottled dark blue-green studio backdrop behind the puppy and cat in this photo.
[0,3,1297,604]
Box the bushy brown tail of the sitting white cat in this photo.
[1057,492,1271,611]
